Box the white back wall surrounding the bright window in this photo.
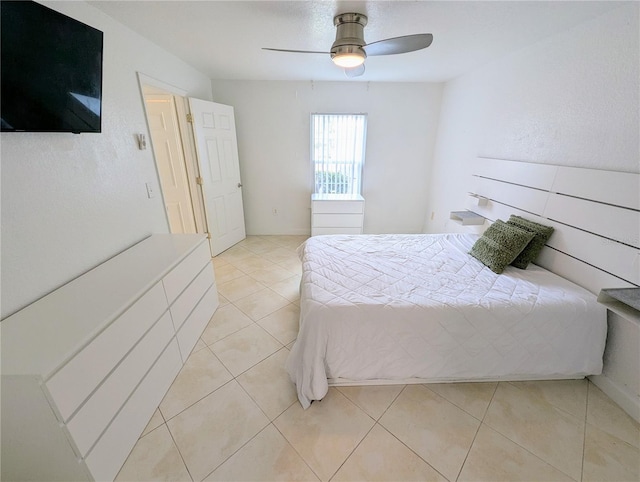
[213,80,442,234]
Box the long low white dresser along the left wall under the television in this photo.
[0,234,218,481]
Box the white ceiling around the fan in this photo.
[89,0,620,82]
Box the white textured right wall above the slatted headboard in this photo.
[426,2,640,232]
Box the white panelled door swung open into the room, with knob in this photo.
[189,98,246,256]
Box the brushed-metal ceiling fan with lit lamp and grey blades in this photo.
[263,13,433,77]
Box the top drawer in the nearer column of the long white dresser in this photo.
[46,283,168,422]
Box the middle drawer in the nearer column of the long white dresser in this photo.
[67,312,174,456]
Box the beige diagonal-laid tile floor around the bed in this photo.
[118,236,640,481]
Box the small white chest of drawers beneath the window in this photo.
[311,194,364,236]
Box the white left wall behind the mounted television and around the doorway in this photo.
[1,2,211,317]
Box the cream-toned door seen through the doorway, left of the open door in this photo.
[144,94,196,234]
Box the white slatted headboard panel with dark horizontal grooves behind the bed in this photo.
[469,158,640,294]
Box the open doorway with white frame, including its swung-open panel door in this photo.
[138,74,246,256]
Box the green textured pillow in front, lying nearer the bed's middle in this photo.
[469,219,534,274]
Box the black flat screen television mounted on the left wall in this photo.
[0,0,103,133]
